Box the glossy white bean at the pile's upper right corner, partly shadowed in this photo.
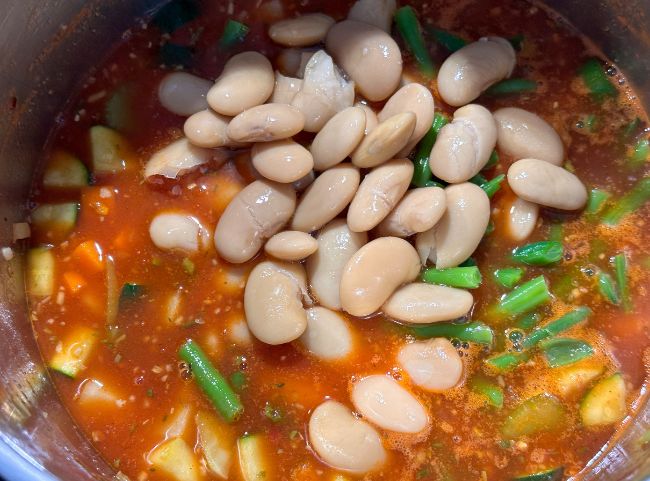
[438,37,517,107]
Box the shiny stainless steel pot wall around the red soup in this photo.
[0,0,650,481]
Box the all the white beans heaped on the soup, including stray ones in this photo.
[145,0,587,473]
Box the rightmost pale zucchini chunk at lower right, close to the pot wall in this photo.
[580,373,627,426]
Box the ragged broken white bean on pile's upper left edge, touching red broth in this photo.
[144,138,211,179]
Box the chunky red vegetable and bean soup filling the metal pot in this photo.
[21,0,650,481]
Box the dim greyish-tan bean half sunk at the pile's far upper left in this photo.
[158,72,212,117]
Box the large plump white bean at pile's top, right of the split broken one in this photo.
[325,20,402,102]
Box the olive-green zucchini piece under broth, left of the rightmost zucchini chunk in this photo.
[501,393,566,439]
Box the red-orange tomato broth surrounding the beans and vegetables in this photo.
[26,0,650,481]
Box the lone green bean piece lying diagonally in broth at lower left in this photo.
[178,339,244,422]
